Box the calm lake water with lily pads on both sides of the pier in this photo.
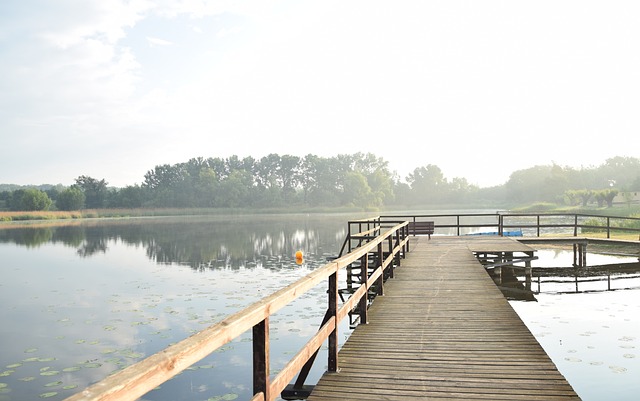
[0,214,640,401]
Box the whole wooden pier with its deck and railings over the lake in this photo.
[67,214,616,401]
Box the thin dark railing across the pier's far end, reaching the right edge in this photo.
[378,212,640,239]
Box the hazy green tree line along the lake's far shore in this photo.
[0,153,640,210]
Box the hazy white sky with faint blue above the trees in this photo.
[0,0,640,186]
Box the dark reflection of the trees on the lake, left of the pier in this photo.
[0,215,346,270]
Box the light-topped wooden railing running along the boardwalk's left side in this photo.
[67,222,409,401]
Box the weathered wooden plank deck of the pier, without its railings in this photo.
[308,236,579,401]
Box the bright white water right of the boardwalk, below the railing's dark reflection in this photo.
[511,290,640,401]
